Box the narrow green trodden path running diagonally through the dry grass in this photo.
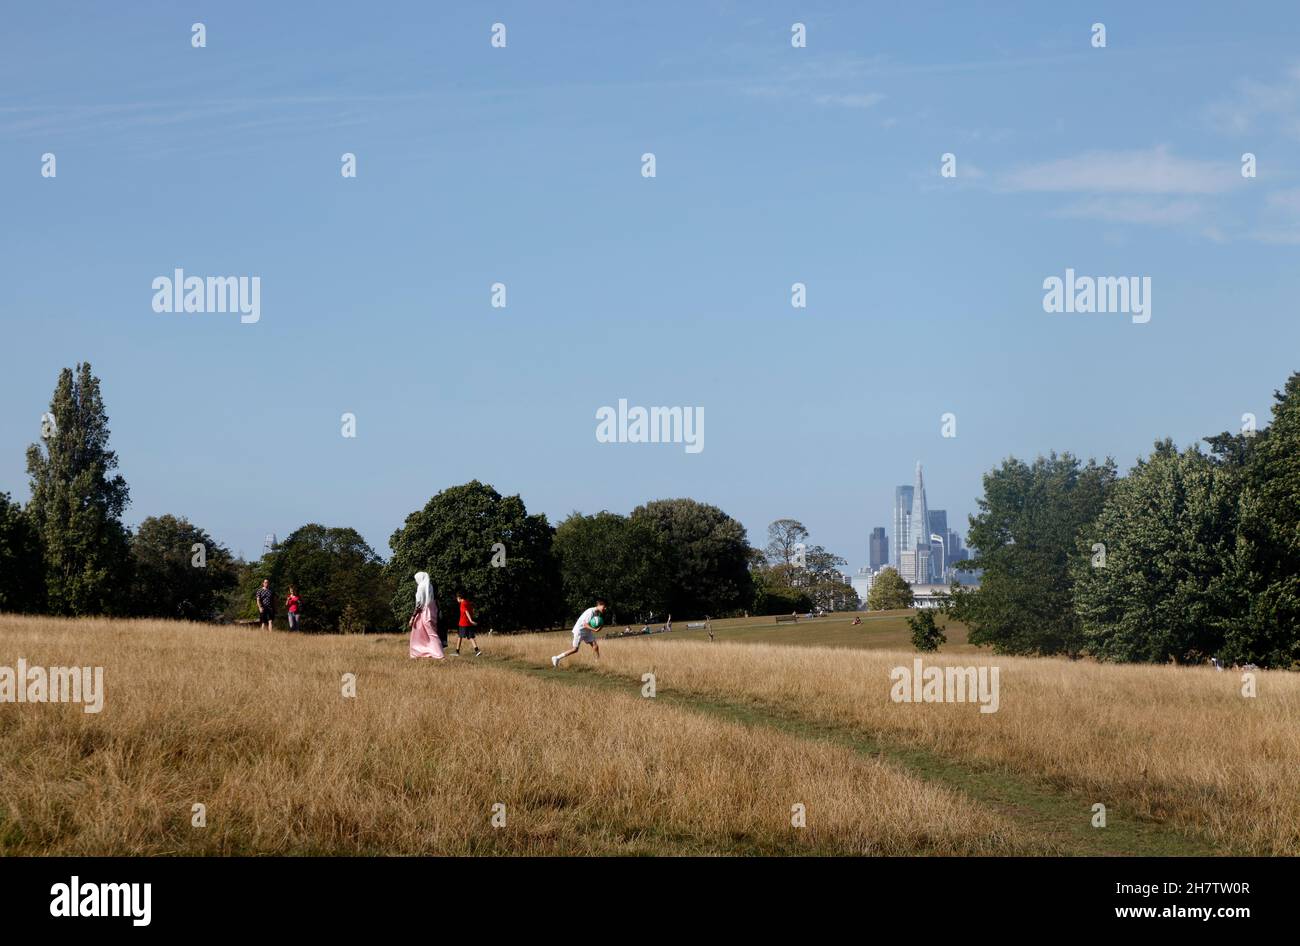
[486,656,1234,856]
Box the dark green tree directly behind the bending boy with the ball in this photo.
[554,512,668,622]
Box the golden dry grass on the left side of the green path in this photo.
[0,616,1045,855]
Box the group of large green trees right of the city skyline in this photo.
[950,372,1300,668]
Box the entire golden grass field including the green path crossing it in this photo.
[0,615,1300,855]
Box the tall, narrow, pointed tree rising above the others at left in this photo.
[27,364,131,615]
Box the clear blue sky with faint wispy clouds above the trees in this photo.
[0,3,1300,569]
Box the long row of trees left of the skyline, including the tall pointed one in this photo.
[0,364,857,632]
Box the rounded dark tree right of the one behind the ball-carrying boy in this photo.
[632,499,754,617]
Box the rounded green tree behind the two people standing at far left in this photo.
[256,522,392,633]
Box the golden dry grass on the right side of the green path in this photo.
[493,634,1300,855]
